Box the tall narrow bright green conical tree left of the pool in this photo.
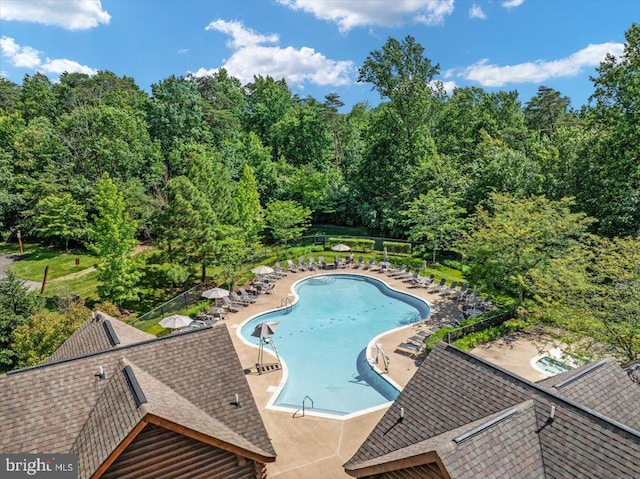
[87,173,140,307]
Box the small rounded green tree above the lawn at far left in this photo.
[30,193,87,251]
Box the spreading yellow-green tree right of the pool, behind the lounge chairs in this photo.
[456,193,593,303]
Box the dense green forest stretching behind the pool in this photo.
[0,24,640,368]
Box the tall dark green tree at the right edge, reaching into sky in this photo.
[574,23,640,236]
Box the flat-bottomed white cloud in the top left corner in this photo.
[0,0,111,30]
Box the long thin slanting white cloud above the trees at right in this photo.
[457,43,624,87]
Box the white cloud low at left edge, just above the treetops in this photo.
[0,36,96,75]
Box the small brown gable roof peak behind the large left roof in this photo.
[45,312,155,363]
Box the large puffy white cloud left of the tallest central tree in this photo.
[193,20,355,87]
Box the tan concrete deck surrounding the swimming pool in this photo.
[215,268,460,479]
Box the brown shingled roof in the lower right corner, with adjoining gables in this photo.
[345,343,640,479]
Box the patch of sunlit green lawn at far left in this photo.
[11,245,98,281]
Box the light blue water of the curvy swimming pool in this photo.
[241,275,429,415]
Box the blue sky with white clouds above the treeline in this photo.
[0,0,640,109]
